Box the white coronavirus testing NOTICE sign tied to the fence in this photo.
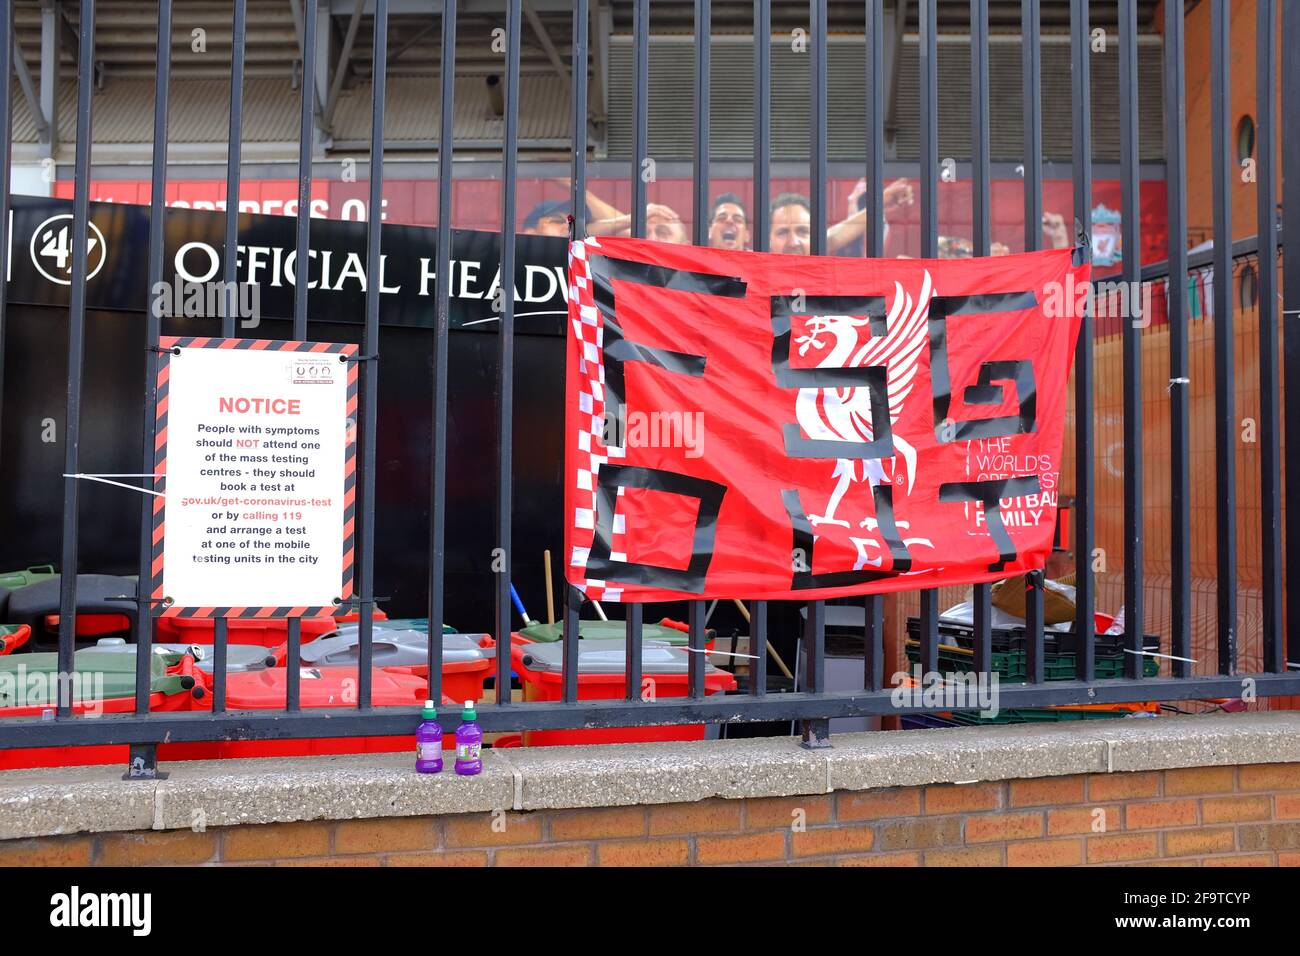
[153,337,356,617]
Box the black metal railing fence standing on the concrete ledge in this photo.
[0,0,1300,769]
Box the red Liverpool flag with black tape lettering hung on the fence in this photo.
[564,238,1088,601]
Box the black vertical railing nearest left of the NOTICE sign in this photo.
[57,0,95,717]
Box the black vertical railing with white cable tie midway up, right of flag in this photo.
[1165,0,1190,678]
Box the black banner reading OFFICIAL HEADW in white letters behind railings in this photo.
[8,196,566,334]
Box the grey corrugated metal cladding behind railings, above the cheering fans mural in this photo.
[608,35,1164,161]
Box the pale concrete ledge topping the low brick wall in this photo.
[0,711,1300,839]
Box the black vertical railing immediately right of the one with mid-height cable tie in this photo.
[1206,0,1239,674]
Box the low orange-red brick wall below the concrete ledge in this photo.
[0,763,1300,866]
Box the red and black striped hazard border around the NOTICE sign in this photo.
[151,336,358,619]
